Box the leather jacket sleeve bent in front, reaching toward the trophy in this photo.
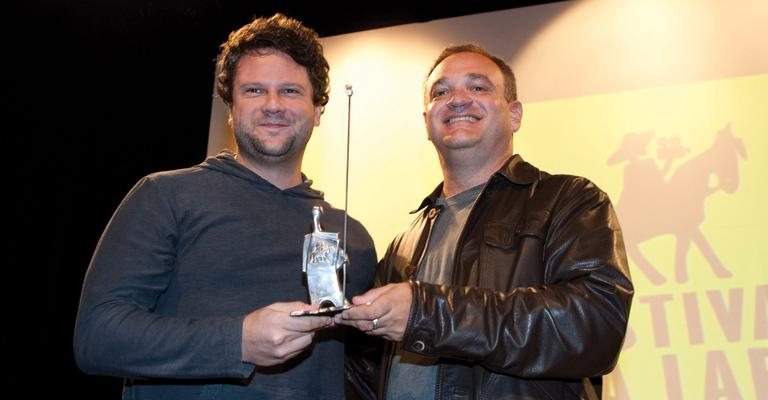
[402,179,634,378]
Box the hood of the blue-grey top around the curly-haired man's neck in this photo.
[199,150,324,200]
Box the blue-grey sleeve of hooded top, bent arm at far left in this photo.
[74,178,253,378]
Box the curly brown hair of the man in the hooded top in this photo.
[216,13,330,106]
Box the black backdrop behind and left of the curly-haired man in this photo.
[10,0,549,399]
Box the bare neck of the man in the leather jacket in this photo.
[440,146,512,198]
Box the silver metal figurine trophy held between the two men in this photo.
[291,206,351,317]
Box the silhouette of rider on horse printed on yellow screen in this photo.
[608,123,747,285]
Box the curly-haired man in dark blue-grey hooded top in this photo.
[74,14,376,399]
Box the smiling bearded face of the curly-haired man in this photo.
[231,51,322,165]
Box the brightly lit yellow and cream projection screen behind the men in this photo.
[209,0,768,400]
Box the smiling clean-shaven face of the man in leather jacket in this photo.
[424,52,522,160]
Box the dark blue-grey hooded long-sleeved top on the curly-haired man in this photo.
[74,152,376,399]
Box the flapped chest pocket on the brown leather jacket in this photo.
[478,212,548,290]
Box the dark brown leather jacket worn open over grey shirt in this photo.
[377,155,634,399]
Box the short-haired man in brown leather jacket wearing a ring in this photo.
[336,45,634,399]
